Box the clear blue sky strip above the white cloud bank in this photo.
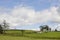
[0,0,59,10]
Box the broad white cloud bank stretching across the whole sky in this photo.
[0,6,60,26]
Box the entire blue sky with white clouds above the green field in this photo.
[0,0,60,30]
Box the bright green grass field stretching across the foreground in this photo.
[0,30,60,40]
